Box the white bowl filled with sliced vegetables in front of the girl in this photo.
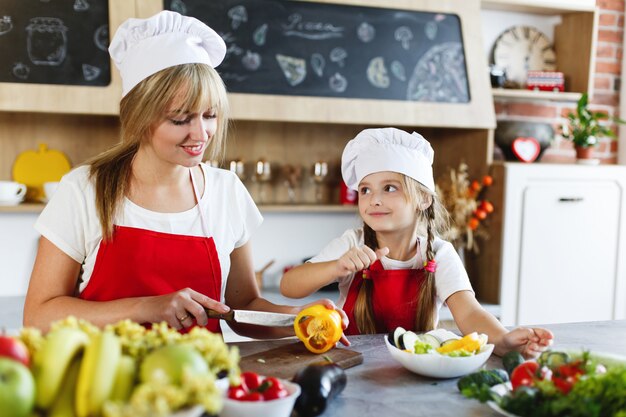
[385,327,494,378]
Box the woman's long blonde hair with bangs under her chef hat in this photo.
[87,64,228,241]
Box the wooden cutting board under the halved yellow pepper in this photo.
[239,342,363,379]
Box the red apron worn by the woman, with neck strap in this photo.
[80,170,222,333]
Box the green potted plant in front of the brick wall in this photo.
[561,93,625,159]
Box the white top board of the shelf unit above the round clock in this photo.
[481,0,596,14]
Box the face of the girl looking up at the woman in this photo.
[359,171,418,233]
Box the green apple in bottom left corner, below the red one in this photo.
[0,358,35,417]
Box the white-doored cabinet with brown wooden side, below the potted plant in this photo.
[473,163,626,325]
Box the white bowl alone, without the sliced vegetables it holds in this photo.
[384,336,493,378]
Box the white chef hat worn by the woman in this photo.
[109,10,226,96]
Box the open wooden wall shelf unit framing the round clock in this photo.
[481,0,598,101]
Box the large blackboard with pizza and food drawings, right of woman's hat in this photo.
[164,0,470,103]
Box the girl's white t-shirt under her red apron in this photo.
[308,228,473,322]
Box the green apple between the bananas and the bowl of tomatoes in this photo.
[139,345,209,385]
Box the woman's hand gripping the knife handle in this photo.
[142,288,230,330]
